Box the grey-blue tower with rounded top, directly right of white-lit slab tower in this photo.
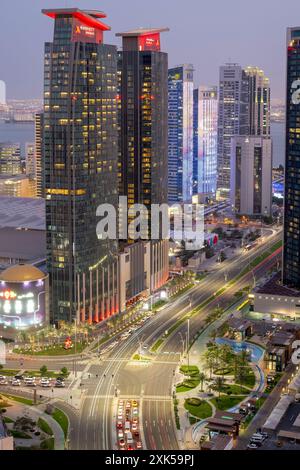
[217,64,249,199]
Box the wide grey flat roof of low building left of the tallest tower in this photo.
[0,196,46,230]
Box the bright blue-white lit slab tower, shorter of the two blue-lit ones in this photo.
[194,87,218,197]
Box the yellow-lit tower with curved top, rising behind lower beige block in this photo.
[245,66,271,137]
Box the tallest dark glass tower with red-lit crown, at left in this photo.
[43,8,118,323]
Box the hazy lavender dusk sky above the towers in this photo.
[0,0,300,99]
